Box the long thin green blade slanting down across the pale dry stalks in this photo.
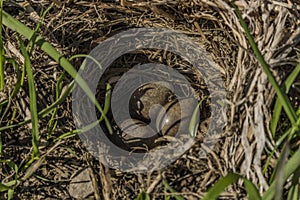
[232,3,297,126]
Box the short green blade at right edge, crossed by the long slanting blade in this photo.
[270,63,300,137]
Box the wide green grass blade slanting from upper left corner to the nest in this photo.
[3,11,112,133]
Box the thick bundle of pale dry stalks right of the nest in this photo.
[211,0,300,192]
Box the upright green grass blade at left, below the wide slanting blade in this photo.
[20,40,40,157]
